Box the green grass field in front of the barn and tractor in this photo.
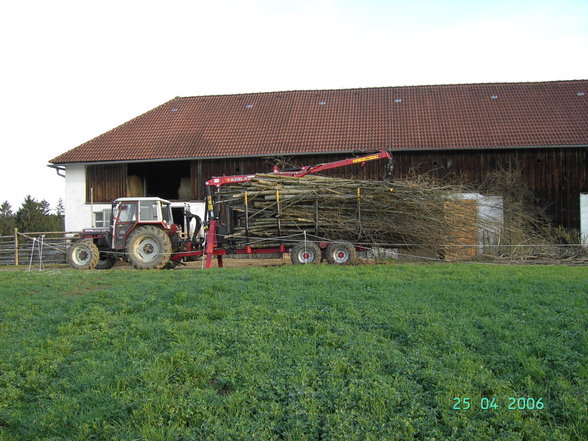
[0,264,588,441]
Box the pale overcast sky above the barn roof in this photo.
[0,0,588,211]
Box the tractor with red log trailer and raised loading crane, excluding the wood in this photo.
[66,150,391,269]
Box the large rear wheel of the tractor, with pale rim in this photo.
[126,225,172,269]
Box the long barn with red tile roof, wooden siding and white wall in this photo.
[49,80,588,235]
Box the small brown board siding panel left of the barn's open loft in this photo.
[86,164,127,203]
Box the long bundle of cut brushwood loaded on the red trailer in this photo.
[217,174,476,253]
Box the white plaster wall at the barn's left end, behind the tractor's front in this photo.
[65,164,110,231]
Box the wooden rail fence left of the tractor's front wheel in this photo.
[0,228,78,265]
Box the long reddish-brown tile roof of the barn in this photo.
[50,80,588,164]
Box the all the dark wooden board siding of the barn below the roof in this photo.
[86,148,588,228]
